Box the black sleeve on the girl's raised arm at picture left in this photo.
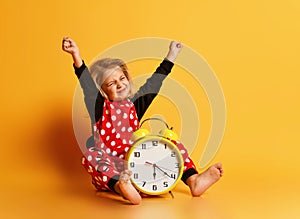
[73,62,104,124]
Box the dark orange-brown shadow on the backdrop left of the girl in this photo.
[40,109,90,191]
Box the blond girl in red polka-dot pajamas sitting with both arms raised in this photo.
[62,37,223,204]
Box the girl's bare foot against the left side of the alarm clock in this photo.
[115,170,142,205]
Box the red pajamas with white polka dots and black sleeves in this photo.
[74,60,197,191]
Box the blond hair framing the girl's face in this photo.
[89,58,132,99]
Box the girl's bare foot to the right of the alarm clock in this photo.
[186,163,224,196]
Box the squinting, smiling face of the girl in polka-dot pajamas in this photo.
[101,68,130,101]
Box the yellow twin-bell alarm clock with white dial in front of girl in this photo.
[126,118,184,195]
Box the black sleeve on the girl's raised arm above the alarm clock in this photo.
[132,59,174,120]
